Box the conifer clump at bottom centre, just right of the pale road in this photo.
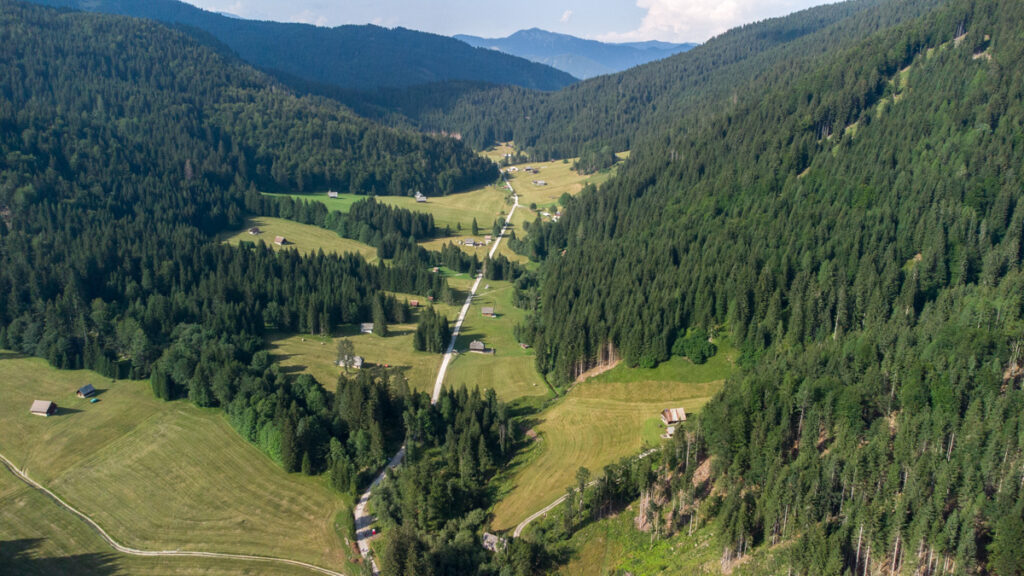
[374,387,516,576]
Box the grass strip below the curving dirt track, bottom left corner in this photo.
[0,468,315,576]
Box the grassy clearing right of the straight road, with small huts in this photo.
[444,280,549,401]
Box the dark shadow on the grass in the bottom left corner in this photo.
[0,538,121,576]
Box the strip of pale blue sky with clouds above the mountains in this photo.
[184,0,827,42]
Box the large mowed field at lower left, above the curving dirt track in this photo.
[0,353,349,567]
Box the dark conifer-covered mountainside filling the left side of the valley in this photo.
[0,0,497,475]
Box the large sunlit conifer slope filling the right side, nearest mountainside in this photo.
[516,0,1024,575]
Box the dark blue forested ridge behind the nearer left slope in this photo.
[31,0,575,90]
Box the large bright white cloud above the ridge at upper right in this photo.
[599,0,827,42]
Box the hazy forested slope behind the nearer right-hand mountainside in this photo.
[406,0,936,153]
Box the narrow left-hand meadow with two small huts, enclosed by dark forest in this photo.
[223,216,377,262]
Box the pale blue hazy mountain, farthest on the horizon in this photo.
[455,28,696,79]
